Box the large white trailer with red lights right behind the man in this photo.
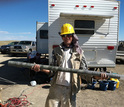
[48,0,120,68]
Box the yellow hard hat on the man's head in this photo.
[60,23,75,35]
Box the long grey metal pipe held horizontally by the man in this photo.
[8,61,124,80]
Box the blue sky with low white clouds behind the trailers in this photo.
[0,0,124,41]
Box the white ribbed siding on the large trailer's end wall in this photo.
[48,0,119,67]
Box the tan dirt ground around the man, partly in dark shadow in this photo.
[0,54,124,107]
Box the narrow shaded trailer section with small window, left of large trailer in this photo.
[36,22,48,54]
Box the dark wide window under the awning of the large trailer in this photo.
[74,20,95,34]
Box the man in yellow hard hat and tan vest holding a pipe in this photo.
[33,23,106,107]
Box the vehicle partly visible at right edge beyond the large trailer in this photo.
[116,41,124,62]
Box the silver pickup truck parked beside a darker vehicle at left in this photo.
[10,41,36,54]
